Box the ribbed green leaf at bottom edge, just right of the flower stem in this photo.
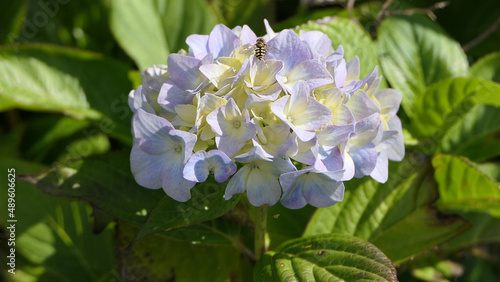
[254,234,398,281]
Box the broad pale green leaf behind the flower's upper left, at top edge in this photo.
[111,0,216,69]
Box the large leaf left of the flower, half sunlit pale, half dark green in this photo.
[0,45,132,143]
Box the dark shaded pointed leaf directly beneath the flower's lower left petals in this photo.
[134,177,240,243]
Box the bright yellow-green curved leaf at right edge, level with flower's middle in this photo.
[412,77,500,138]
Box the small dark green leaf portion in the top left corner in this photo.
[0,0,28,44]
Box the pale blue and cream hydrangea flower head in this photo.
[129,21,404,209]
